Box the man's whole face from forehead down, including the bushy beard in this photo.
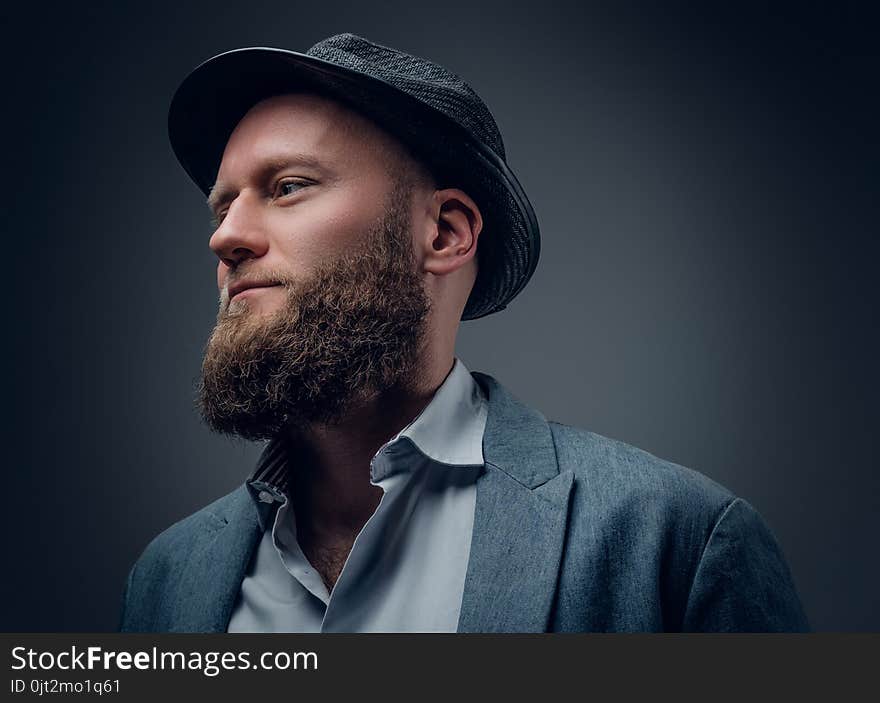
[200,94,430,439]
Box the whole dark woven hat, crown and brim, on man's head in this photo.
[168,33,540,320]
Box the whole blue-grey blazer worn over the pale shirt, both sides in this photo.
[119,372,809,632]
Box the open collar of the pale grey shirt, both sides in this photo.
[246,357,488,530]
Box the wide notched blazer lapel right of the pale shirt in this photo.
[458,372,574,632]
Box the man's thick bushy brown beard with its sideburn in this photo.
[198,179,431,440]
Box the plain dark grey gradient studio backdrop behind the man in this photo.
[0,1,880,631]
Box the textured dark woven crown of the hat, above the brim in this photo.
[306,32,507,161]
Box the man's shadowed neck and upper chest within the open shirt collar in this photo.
[289,354,454,542]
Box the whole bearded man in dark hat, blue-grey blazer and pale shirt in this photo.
[120,34,808,632]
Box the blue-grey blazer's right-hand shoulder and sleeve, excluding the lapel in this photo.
[548,422,809,632]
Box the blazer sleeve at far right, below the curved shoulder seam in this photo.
[682,498,810,632]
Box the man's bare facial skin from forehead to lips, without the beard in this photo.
[209,94,416,314]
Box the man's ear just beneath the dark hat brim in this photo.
[423,188,483,276]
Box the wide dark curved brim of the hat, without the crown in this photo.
[168,47,540,320]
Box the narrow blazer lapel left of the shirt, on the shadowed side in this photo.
[170,485,262,632]
